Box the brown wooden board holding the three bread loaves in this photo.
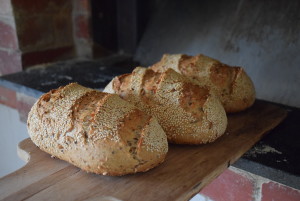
[0,101,287,201]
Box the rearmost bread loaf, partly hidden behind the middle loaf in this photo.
[151,54,255,113]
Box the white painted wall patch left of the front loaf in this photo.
[0,104,28,178]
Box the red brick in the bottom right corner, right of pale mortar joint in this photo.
[262,182,300,201]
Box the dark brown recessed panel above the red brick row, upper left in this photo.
[13,0,73,52]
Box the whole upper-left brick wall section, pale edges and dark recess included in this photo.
[0,0,92,75]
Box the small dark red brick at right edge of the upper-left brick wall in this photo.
[75,15,90,39]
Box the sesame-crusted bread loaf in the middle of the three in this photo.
[104,67,227,144]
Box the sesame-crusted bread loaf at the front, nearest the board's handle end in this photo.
[28,83,168,175]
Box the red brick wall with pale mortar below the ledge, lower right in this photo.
[195,167,300,201]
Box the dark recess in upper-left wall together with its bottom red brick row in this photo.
[11,0,75,67]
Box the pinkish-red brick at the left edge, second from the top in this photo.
[0,19,18,50]
